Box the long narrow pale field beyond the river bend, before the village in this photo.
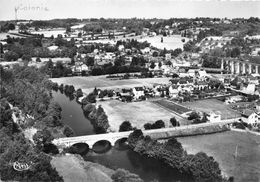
[51,75,169,93]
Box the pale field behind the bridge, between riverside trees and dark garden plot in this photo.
[98,100,185,131]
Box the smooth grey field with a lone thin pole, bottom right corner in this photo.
[178,131,260,182]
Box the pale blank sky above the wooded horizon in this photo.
[0,0,260,20]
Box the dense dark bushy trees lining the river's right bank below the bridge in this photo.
[128,130,233,182]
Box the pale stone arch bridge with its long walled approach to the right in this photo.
[52,119,235,149]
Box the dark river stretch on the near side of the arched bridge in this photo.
[84,148,192,182]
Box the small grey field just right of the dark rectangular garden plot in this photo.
[182,99,240,120]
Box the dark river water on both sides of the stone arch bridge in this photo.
[52,91,190,182]
